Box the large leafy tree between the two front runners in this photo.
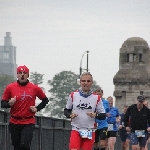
[45,71,99,118]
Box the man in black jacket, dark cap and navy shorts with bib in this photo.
[124,95,150,150]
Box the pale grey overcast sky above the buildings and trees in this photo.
[0,0,150,97]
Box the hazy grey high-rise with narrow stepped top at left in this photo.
[0,32,17,79]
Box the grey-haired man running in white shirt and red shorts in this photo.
[64,72,106,150]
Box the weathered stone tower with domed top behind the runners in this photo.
[113,37,150,111]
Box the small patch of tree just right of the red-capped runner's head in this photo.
[30,72,44,90]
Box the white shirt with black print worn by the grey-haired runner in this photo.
[66,92,105,130]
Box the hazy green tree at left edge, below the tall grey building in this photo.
[0,74,15,96]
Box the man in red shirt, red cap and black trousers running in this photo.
[1,66,48,150]
